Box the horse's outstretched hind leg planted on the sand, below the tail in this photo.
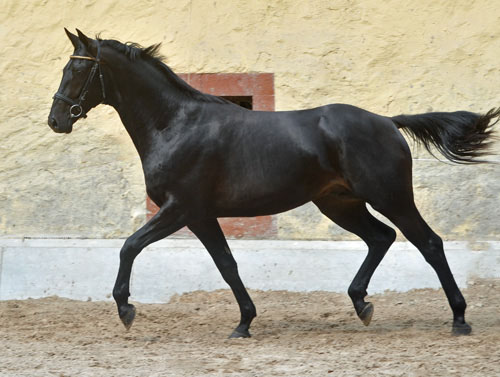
[373,200,471,335]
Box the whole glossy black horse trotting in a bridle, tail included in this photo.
[48,30,500,337]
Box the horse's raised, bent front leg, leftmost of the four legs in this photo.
[113,198,186,330]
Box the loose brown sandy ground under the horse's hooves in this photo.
[0,279,500,377]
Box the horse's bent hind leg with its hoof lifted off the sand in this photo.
[314,195,396,326]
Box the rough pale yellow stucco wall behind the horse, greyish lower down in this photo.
[0,0,500,240]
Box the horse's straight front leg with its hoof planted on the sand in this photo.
[188,219,257,338]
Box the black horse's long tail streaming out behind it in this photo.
[391,108,500,164]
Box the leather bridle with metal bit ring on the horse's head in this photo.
[53,43,106,119]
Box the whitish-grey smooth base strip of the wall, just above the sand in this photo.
[0,239,500,303]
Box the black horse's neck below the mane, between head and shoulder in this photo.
[104,56,187,161]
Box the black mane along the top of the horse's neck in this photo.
[97,36,232,103]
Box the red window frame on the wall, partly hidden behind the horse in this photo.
[146,73,276,238]
